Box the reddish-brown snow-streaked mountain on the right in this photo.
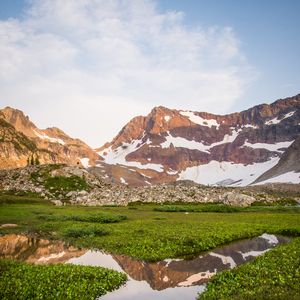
[96,95,300,186]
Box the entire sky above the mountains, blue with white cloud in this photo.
[0,0,300,147]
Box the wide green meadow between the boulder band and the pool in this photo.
[0,199,300,261]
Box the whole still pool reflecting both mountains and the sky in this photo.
[0,234,290,300]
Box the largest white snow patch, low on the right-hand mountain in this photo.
[177,157,279,186]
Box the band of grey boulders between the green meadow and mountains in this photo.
[0,165,300,206]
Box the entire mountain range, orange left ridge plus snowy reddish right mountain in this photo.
[0,95,300,188]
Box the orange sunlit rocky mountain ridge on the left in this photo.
[0,107,101,169]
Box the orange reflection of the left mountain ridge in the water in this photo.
[0,234,86,264]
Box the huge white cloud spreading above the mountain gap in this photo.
[0,0,254,146]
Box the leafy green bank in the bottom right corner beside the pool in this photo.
[199,238,300,300]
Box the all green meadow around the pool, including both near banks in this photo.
[0,194,300,299]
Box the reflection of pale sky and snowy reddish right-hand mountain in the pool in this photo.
[69,234,289,300]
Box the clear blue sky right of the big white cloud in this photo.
[160,0,300,109]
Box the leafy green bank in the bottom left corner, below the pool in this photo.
[0,260,126,300]
